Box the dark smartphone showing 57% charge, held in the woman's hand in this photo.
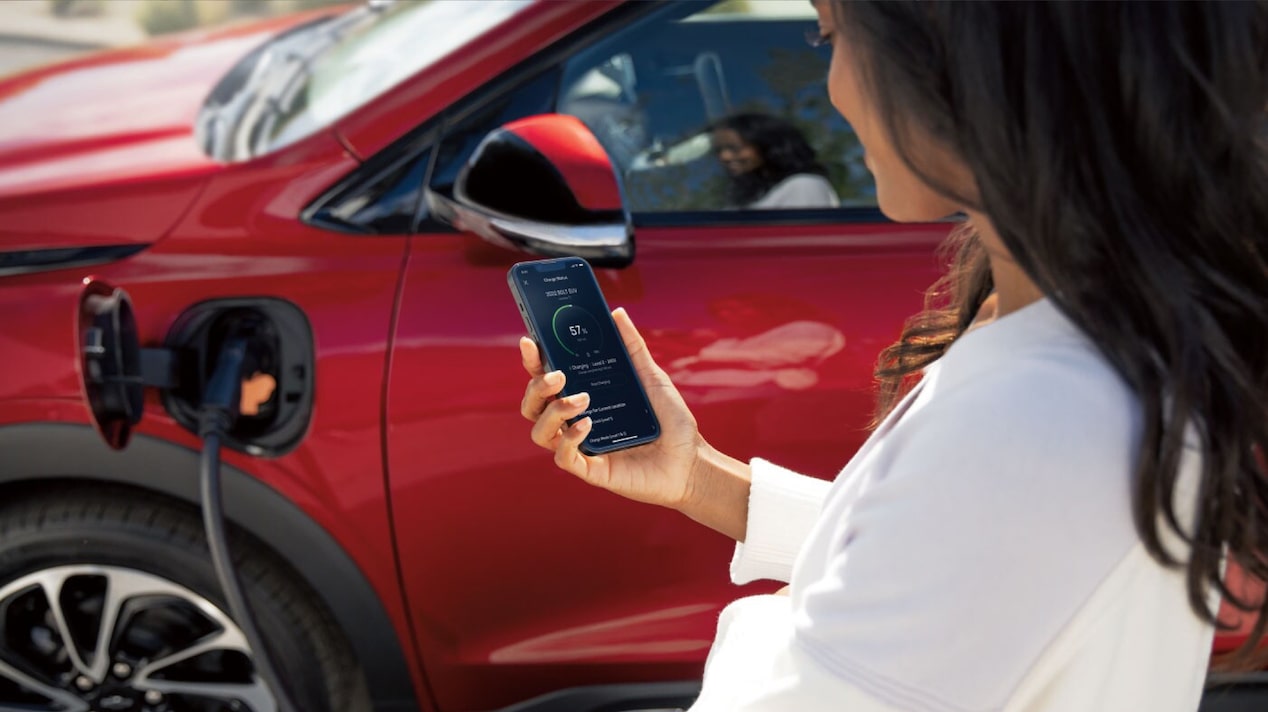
[506,257,661,455]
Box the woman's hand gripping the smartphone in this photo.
[520,309,709,511]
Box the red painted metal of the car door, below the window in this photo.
[387,219,948,708]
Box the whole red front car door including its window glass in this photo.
[387,4,948,708]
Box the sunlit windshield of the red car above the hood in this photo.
[209,0,531,160]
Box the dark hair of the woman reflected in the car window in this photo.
[709,111,828,205]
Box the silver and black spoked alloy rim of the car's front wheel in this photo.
[0,565,276,712]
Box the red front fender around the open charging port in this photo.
[0,103,429,708]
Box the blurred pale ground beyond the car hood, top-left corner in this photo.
[0,0,146,76]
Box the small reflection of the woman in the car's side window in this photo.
[710,113,841,209]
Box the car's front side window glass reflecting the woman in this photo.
[558,0,876,212]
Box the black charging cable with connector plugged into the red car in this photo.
[198,336,298,712]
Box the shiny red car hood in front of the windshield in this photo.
[0,10,342,250]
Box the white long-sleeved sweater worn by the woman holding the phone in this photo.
[692,300,1213,712]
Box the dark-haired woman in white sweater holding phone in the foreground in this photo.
[521,0,1268,712]
